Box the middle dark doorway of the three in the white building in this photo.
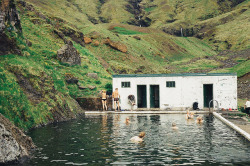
[150,85,160,108]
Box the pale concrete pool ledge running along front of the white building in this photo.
[85,111,209,115]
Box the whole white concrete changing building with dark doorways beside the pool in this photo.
[113,73,237,110]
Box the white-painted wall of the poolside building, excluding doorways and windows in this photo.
[113,75,237,110]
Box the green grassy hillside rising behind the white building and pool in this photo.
[0,0,250,129]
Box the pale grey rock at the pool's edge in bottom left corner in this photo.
[0,114,35,165]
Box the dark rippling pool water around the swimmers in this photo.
[23,114,250,166]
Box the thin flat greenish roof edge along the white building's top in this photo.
[113,73,237,78]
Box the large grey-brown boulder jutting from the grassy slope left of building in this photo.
[57,42,81,65]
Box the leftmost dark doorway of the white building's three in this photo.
[137,85,147,108]
